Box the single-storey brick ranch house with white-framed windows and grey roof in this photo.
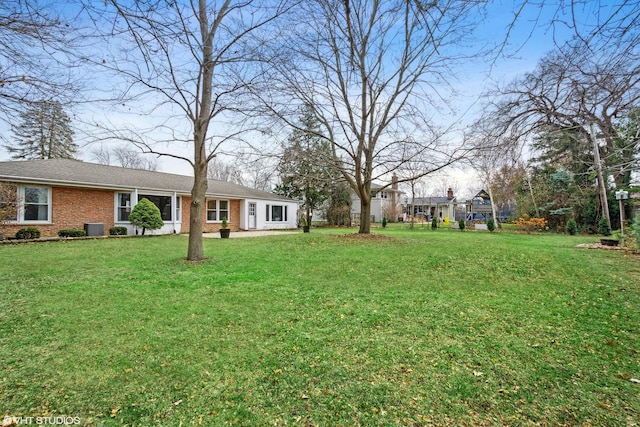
[0,159,298,237]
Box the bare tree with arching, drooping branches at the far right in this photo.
[485,29,640,231]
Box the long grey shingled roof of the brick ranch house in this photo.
[0,159,294,201]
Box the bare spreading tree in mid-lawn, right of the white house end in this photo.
[259,0,482,233]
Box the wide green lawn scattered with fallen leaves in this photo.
[0,228,640,426]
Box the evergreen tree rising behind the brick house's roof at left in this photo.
[5,101,78,160]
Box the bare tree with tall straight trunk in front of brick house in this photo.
[86,0,294,261]
